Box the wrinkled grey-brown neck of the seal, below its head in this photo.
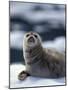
[25,45,43,64]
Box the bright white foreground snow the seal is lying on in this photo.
[10,64,65,88]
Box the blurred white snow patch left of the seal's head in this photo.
[10,31,25,49]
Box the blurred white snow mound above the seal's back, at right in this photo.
[42,37,65,52]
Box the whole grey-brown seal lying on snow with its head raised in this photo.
[18,32,66,80]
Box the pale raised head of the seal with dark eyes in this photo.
[23,32,41,48]
